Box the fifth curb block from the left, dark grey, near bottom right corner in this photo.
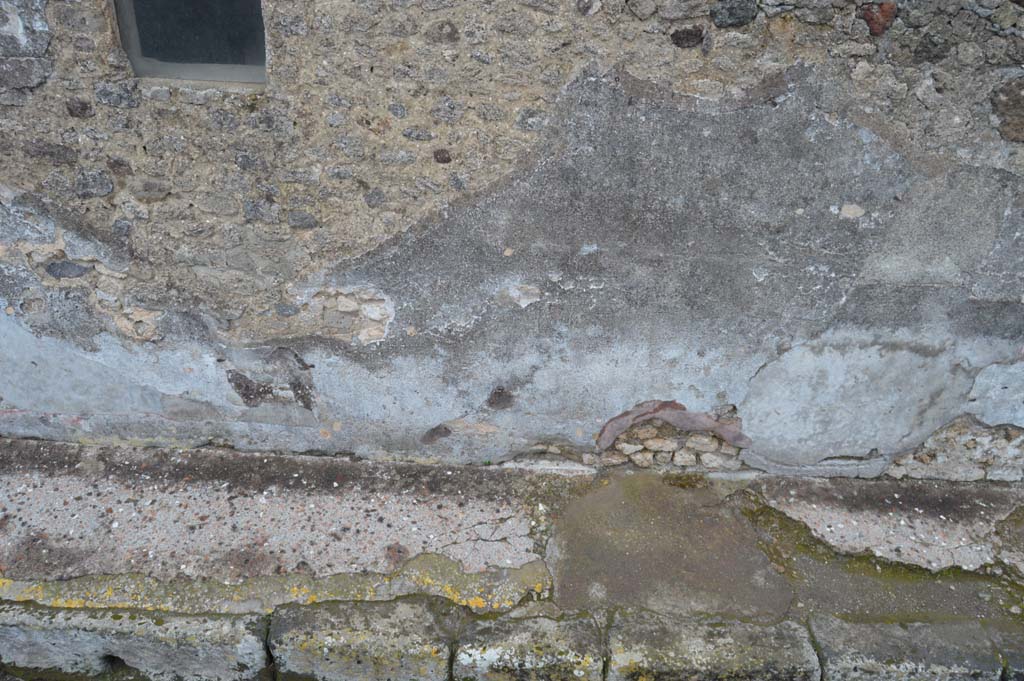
[811,618,1002,681]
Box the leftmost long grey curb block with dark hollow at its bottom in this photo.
[0,602,269,681]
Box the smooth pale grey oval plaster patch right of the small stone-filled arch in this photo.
[740,332,972,466]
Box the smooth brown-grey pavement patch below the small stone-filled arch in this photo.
[547,472,794,621]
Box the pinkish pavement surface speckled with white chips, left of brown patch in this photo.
[0,440,590,582]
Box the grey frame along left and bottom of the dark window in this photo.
[114,0,266,83]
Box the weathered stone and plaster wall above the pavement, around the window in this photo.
[0,0,1024,476]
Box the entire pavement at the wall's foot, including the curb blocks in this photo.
[0,439,1024,681]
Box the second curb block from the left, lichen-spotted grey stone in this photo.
[269,599,454,681]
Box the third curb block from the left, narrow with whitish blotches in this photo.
[453,618,603,681]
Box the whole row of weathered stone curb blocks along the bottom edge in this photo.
[6,596,1024,681]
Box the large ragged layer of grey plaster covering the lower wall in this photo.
[0,68,1022,475]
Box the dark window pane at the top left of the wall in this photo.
[131,0,265,66]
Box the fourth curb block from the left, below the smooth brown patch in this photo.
[607,612,820,681]
